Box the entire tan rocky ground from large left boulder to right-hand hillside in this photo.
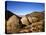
[6,12,45,33]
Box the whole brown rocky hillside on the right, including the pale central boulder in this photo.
[21,12,45,32]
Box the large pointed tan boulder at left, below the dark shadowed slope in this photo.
[7,15,19,33]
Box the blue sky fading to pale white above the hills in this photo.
[7,1,45,15]
